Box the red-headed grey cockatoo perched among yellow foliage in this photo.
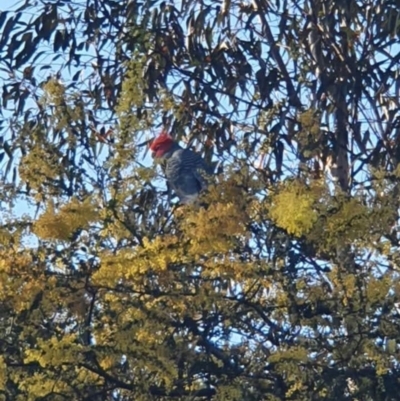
[150,130,213,204]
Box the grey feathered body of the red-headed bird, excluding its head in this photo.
[164,144,212,203]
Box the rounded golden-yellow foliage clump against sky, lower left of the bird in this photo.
[33,199,98,241]
